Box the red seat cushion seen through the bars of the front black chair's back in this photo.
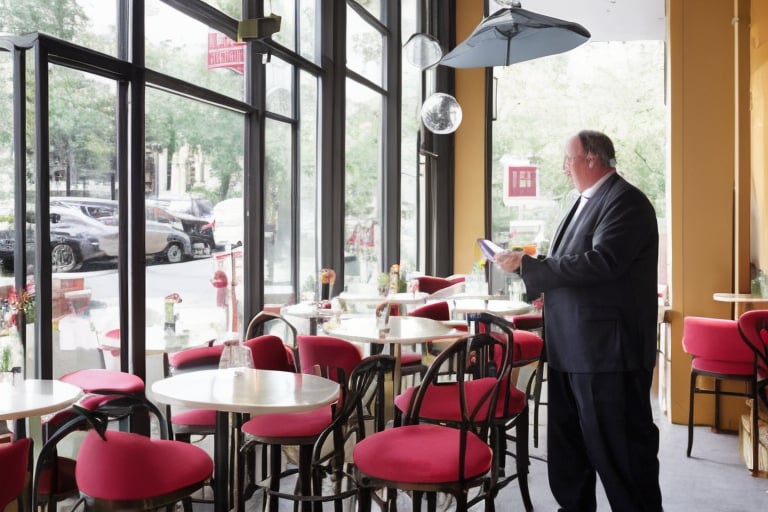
[395,377,527,421]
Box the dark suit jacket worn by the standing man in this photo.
[521,174,659,373]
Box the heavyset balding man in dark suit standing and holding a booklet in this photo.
[496,130,662,512]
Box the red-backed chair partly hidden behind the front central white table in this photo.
[241,335,362,512]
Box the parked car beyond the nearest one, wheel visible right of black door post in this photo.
[51,197,201,263]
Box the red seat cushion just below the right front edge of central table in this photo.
[242,406,333,438]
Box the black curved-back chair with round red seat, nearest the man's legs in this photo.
[353,333,511,512]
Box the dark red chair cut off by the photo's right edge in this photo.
[738,310,768,476]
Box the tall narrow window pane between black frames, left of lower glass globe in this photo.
[400,0,424,271]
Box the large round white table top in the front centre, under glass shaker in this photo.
[152,368,339,414]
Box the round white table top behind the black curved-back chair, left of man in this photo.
[323,316,467,345]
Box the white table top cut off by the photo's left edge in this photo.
[0,375,83,420]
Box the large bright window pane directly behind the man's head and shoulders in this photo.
[491,41,667,283]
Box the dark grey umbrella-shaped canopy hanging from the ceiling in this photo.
[440,7,591,68]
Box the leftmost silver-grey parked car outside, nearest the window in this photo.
[0,207,117,272]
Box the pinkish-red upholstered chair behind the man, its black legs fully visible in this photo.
[682,316,756,457]
